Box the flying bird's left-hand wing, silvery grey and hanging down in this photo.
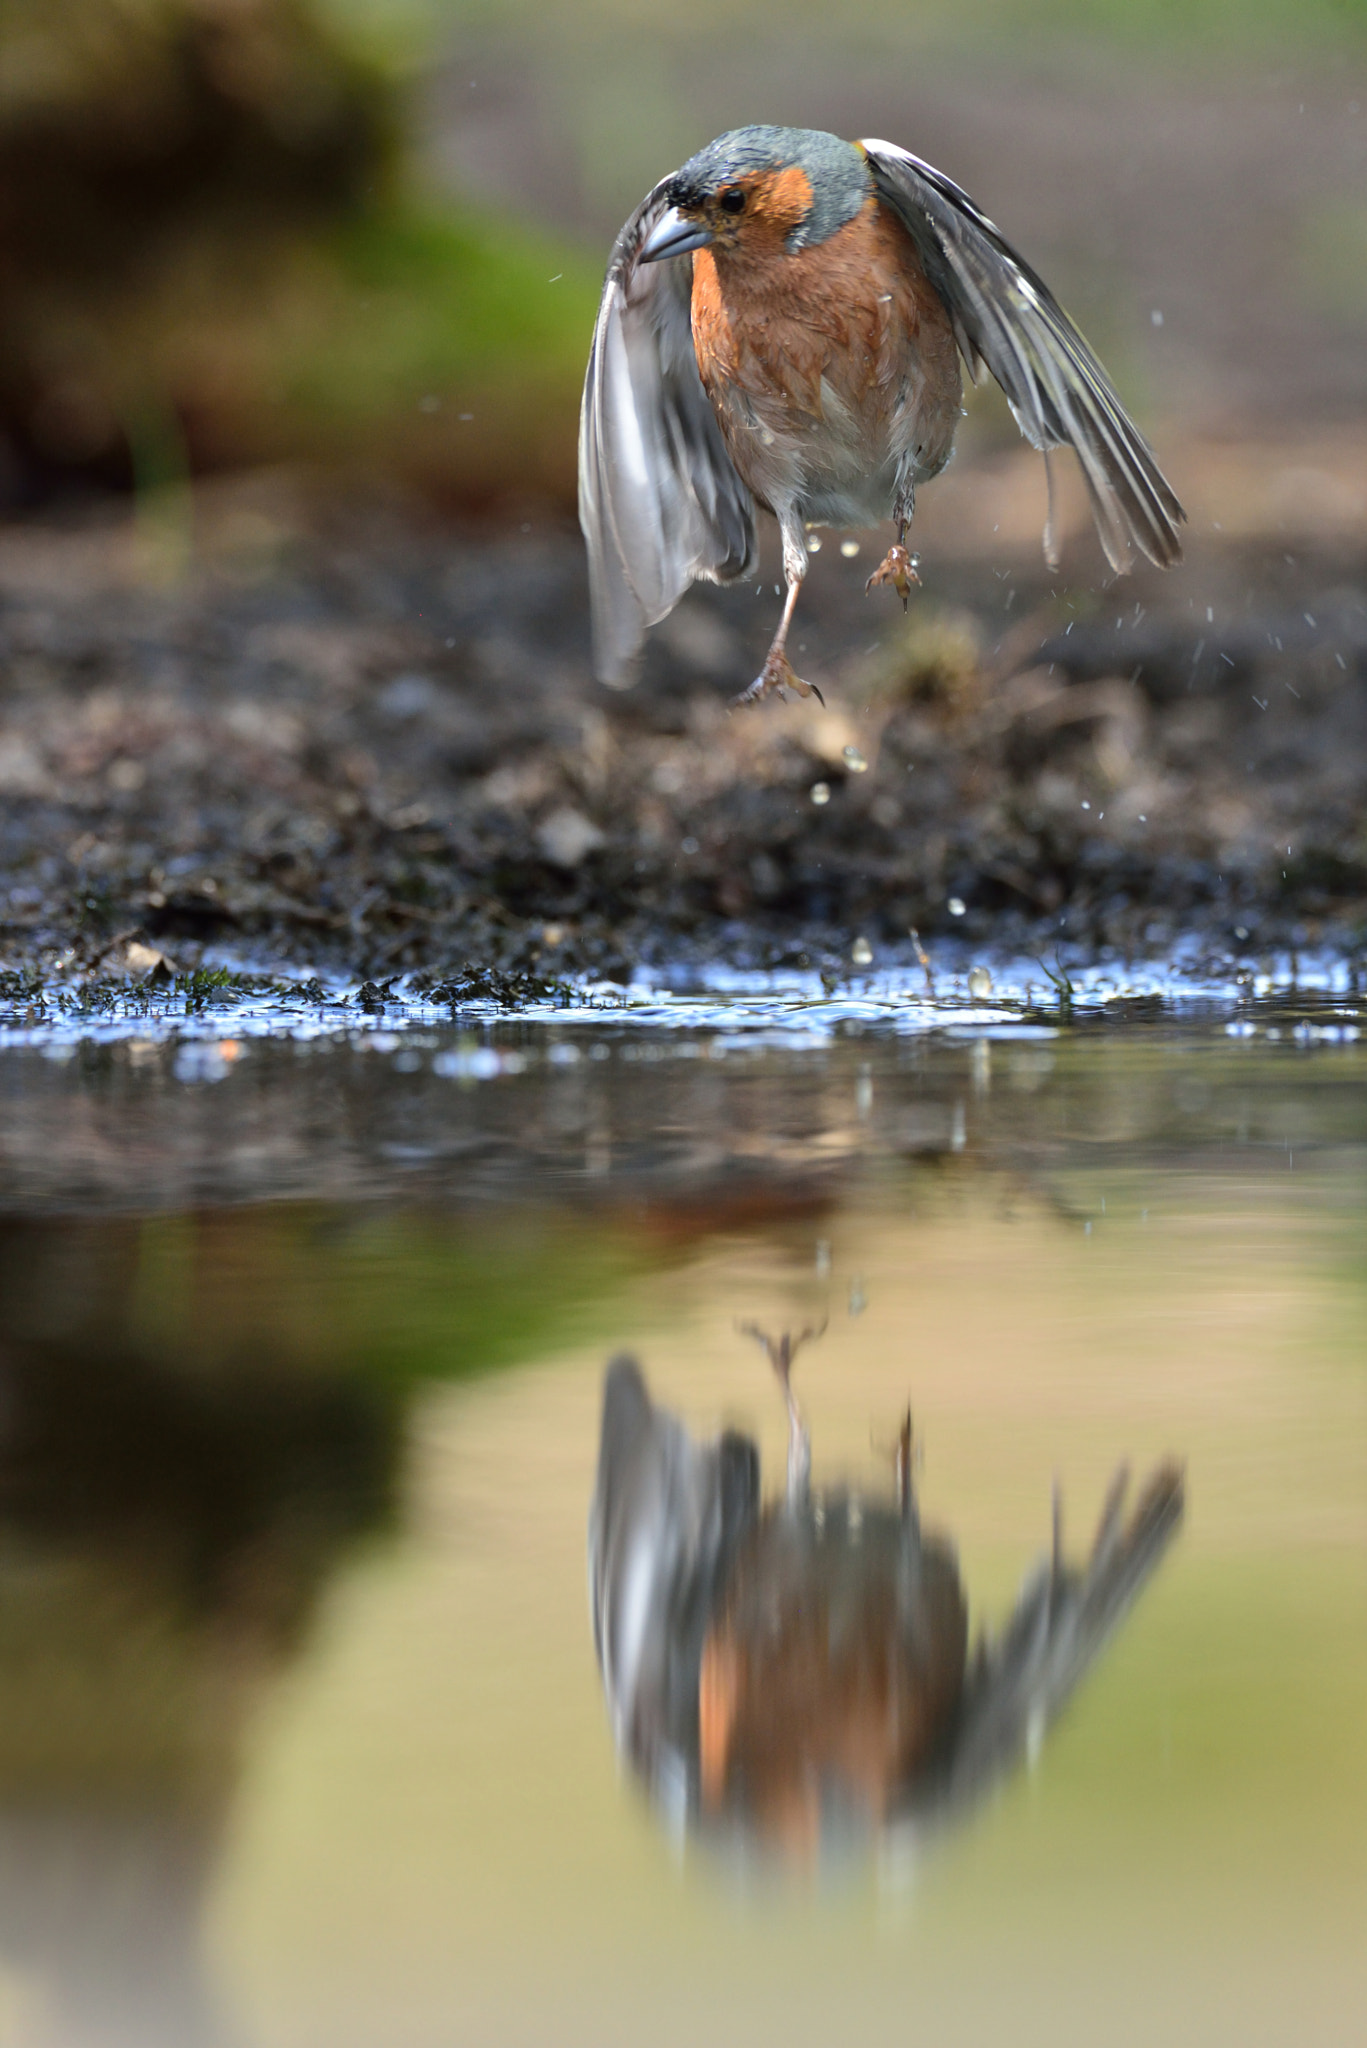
[580,184,754,682]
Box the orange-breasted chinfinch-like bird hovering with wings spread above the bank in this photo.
[578,127,1187,702]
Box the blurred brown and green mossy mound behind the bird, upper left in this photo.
[0,0,598,500]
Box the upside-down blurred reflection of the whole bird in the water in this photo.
[588,1331,1183,1862]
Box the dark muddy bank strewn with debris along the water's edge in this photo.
[0,463,1367,981]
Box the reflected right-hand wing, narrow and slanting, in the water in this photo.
[904,1464,1185,1821]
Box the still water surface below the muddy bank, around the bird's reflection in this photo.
[0,995,1367,2048]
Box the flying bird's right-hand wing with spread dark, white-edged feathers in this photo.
[861,141,1187,573]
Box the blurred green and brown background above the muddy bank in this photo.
[0,0,1367,510]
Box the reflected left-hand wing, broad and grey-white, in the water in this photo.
[588,1358,760,1810]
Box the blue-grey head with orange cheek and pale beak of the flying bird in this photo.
[641,127,871,262]
